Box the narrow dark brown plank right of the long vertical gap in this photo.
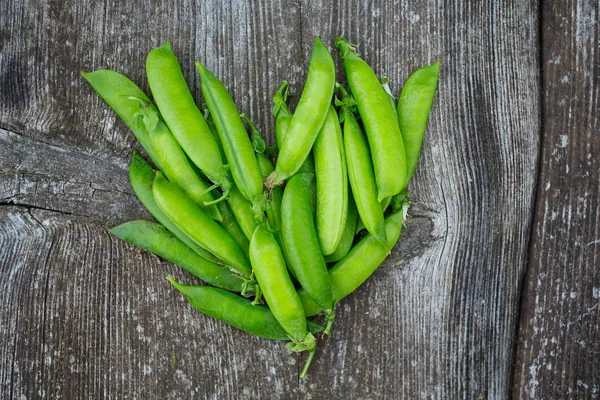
[512,1,600,399]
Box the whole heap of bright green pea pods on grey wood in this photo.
[83,37,440,376]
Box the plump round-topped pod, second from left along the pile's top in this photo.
[146,42,230,192]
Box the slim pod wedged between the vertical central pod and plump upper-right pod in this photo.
[340,87,387,248]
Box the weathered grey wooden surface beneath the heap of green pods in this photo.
[0,0,600,399]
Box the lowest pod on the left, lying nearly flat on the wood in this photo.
[167,276,323,340]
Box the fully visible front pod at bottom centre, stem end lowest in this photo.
[250,224,315,344]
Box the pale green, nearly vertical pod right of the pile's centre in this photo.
[313,105,348,255]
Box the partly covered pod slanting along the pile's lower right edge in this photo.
[298,204,408,317]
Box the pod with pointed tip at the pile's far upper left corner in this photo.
[81,69,162,171]
